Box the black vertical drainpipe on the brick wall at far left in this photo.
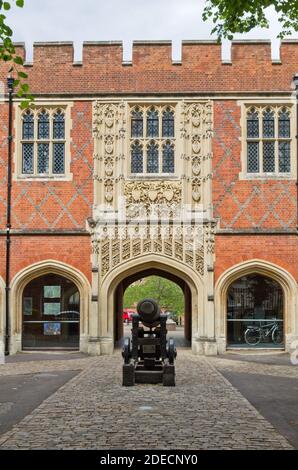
[5,77,14,356]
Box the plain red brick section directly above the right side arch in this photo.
[215,235,298,282]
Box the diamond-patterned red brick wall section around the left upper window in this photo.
[0,102,93,230]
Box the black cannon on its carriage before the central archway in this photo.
[122,299,177,386]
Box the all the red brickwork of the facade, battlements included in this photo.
[0,43,298,286]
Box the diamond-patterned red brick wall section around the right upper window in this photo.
[212,101,297,229]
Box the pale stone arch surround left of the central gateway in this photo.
[10,260,91,354]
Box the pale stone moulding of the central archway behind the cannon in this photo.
[99,254,204,354]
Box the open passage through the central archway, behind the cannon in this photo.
[114,269,192,347]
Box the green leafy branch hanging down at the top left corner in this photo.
[0,0,33,108]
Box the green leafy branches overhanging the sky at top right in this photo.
[203,0,298,40]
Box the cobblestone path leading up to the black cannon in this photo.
[0,349,291,450]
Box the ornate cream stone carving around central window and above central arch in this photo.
[90,100,215,279]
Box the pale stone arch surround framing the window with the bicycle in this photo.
[215,259,298,353]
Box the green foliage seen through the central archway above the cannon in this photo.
[123,276,184,315]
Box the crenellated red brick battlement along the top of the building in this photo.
[0,40,298,95]
